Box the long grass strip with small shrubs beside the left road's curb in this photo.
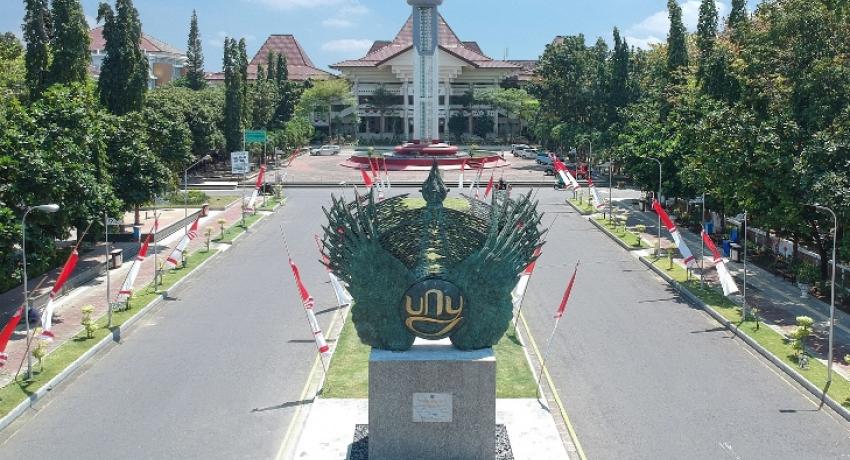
[0,250,215,417]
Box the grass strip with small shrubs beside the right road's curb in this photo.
[654,258,850,408]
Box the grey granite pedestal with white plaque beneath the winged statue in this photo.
[369,339,496,460]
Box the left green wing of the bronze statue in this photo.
[322,194,415,350]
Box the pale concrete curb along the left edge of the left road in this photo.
[0,210,266,431]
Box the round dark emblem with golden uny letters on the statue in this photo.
[402,279,465,340]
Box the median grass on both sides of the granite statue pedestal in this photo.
[323,315,537,398]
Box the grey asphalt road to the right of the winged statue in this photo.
[523,190,850,460]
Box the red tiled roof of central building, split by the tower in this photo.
[330,15,517,69]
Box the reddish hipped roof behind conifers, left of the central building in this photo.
[206,34,333,84]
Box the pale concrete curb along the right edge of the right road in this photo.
[639,256,850,421]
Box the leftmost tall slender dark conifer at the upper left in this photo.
[23,0,52,99]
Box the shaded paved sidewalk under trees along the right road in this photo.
[618,203,850,377]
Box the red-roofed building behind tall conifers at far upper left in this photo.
[89,26,187,88]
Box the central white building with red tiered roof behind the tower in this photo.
[330,14,527,139]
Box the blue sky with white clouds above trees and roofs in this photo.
[0,0,757,71]
